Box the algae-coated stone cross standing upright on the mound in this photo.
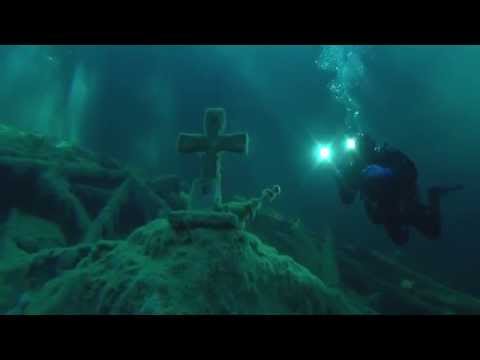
[177,108,248,210]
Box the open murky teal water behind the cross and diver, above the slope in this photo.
[0,45,480,310]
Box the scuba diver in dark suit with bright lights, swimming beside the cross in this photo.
[333,133,463,245]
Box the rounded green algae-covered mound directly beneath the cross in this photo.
[0,219,367,314]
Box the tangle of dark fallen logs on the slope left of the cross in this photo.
[0,127,172,244]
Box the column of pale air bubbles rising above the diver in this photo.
[315,45,367,131]
